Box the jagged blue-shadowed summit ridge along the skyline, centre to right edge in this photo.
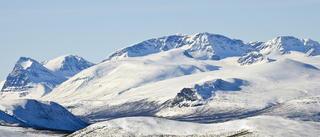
[102,32,320,62]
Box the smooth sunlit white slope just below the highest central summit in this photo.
[44,49,219,101]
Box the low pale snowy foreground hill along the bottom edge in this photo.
[69,116,320,137]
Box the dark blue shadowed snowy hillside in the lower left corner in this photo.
[0,100,87,131]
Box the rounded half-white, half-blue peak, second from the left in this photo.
[42,55,95,77]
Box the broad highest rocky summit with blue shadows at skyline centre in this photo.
[103,32,251,62]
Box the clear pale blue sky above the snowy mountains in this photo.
[0,0,320,81]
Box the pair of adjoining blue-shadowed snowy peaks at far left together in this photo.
[1,55,94,98]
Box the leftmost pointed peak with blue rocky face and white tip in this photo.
[1,57,66,98]
